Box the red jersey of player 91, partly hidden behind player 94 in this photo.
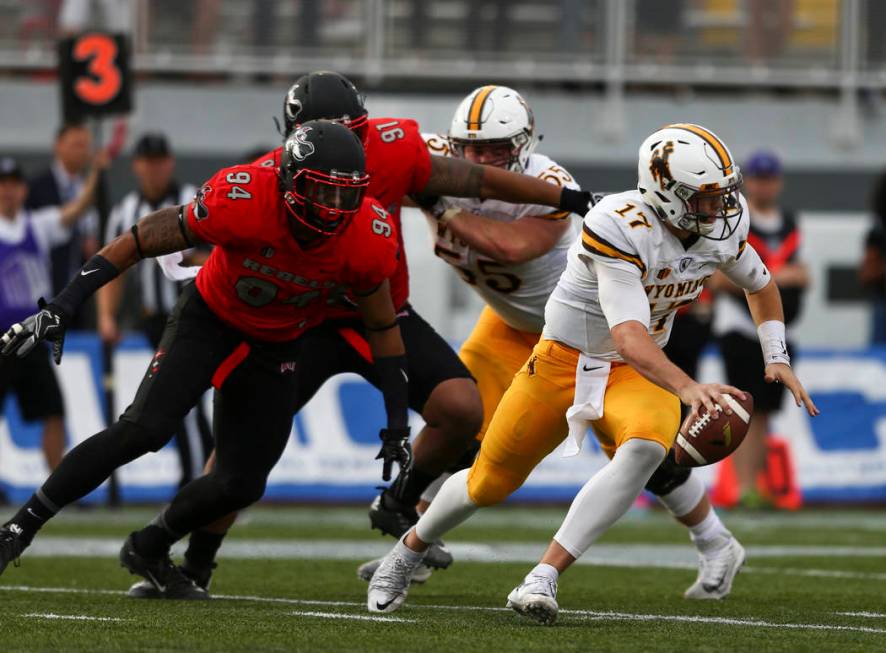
[254,118,431,317]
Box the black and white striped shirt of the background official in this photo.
[105,184,197,315]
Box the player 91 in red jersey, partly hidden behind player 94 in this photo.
[166,71,589,596]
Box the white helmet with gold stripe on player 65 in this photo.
[449,85,539,172]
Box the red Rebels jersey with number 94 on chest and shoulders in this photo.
[188,165,399,342]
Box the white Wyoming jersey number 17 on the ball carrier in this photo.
[544,190,750,361]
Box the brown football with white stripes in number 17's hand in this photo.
[674,392,754,467]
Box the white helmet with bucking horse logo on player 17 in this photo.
[637,123,743,240]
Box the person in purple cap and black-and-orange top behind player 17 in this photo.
[710,151,809,508]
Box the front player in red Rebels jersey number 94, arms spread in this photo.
[0,121,411,598]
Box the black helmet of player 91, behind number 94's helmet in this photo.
[283,70,369,142]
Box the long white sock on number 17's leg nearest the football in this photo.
[554,438,665,558]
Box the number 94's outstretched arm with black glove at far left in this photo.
[0,207,201,364]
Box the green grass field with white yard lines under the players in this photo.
[0,508,886,653]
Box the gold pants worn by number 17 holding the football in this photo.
[468,339,680,506]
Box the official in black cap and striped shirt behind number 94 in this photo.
[97,133,212,485]
